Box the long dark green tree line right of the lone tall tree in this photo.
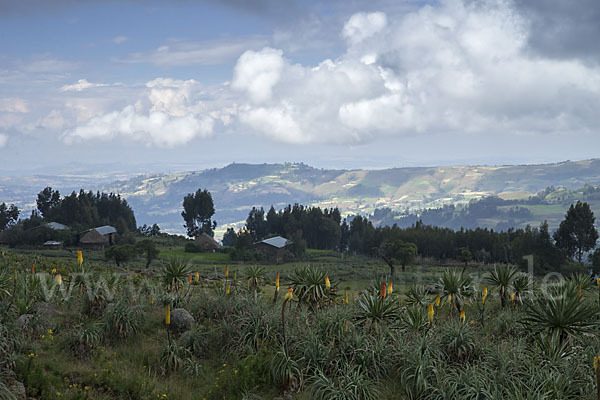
[229,202,600,273]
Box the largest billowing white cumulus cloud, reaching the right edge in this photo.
[231,0,600,143]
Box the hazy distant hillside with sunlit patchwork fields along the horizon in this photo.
[0,159,600,232]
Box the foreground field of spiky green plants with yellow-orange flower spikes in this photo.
[0,249,600,400]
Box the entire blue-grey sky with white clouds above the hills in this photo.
[0,0,600,174]
